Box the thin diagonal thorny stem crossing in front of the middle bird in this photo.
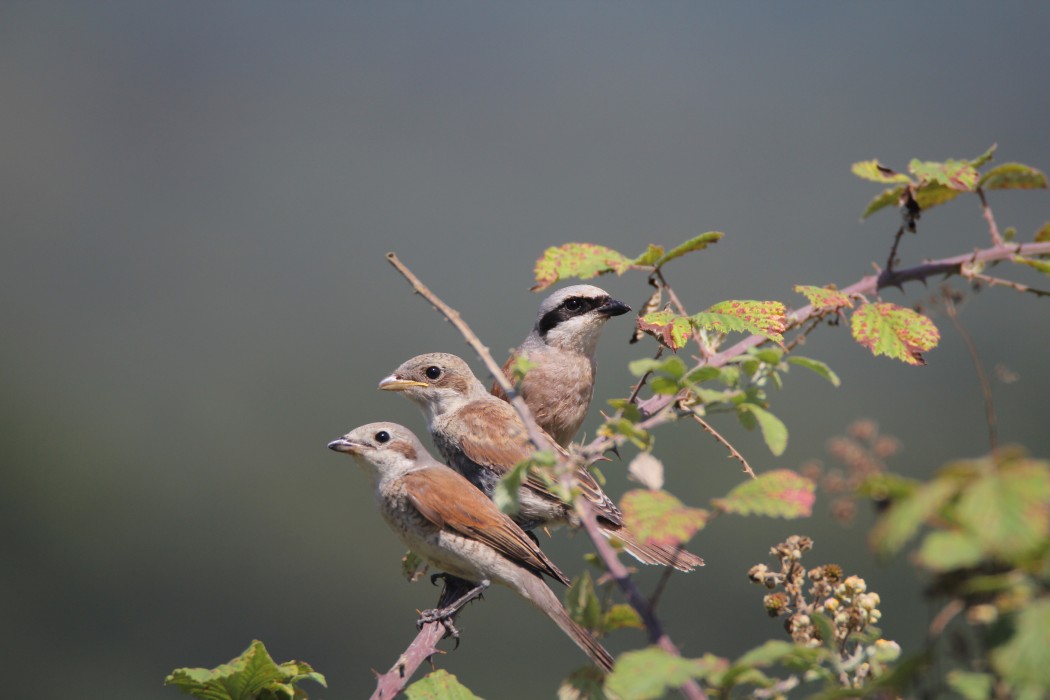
[386,253,707,700]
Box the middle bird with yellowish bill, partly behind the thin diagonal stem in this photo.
[379,353,704,571]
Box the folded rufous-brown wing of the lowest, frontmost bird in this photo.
[404,467,569,585]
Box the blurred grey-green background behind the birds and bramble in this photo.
[0,0,1050,698]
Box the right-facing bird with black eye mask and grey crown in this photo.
[491,284,631,447]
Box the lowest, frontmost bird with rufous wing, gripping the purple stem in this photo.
[328,423,613,672]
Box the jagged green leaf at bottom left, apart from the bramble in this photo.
[164,640,328,700]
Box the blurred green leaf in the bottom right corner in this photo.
[991,597,1050,693]
